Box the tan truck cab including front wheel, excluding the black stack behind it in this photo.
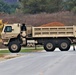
[1,24,21,53]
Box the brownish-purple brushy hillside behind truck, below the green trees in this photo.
[0,11,76,26]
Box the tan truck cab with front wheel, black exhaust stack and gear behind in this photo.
[1,23,32,53]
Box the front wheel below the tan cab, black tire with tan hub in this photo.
[8,41,21,53]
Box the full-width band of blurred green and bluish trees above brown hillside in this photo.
[0,0,76,14]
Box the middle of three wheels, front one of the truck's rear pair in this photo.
[44,41,55,52]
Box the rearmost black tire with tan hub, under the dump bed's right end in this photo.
[59,40,71,51]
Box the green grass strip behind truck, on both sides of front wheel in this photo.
[0,47,43,53]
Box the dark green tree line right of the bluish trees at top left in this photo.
[20,0,76,14]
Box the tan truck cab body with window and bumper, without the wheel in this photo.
[1,24,20,45]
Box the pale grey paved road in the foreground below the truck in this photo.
[0,48,76,75]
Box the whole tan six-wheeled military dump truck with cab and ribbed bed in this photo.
[1,24,76,53]
